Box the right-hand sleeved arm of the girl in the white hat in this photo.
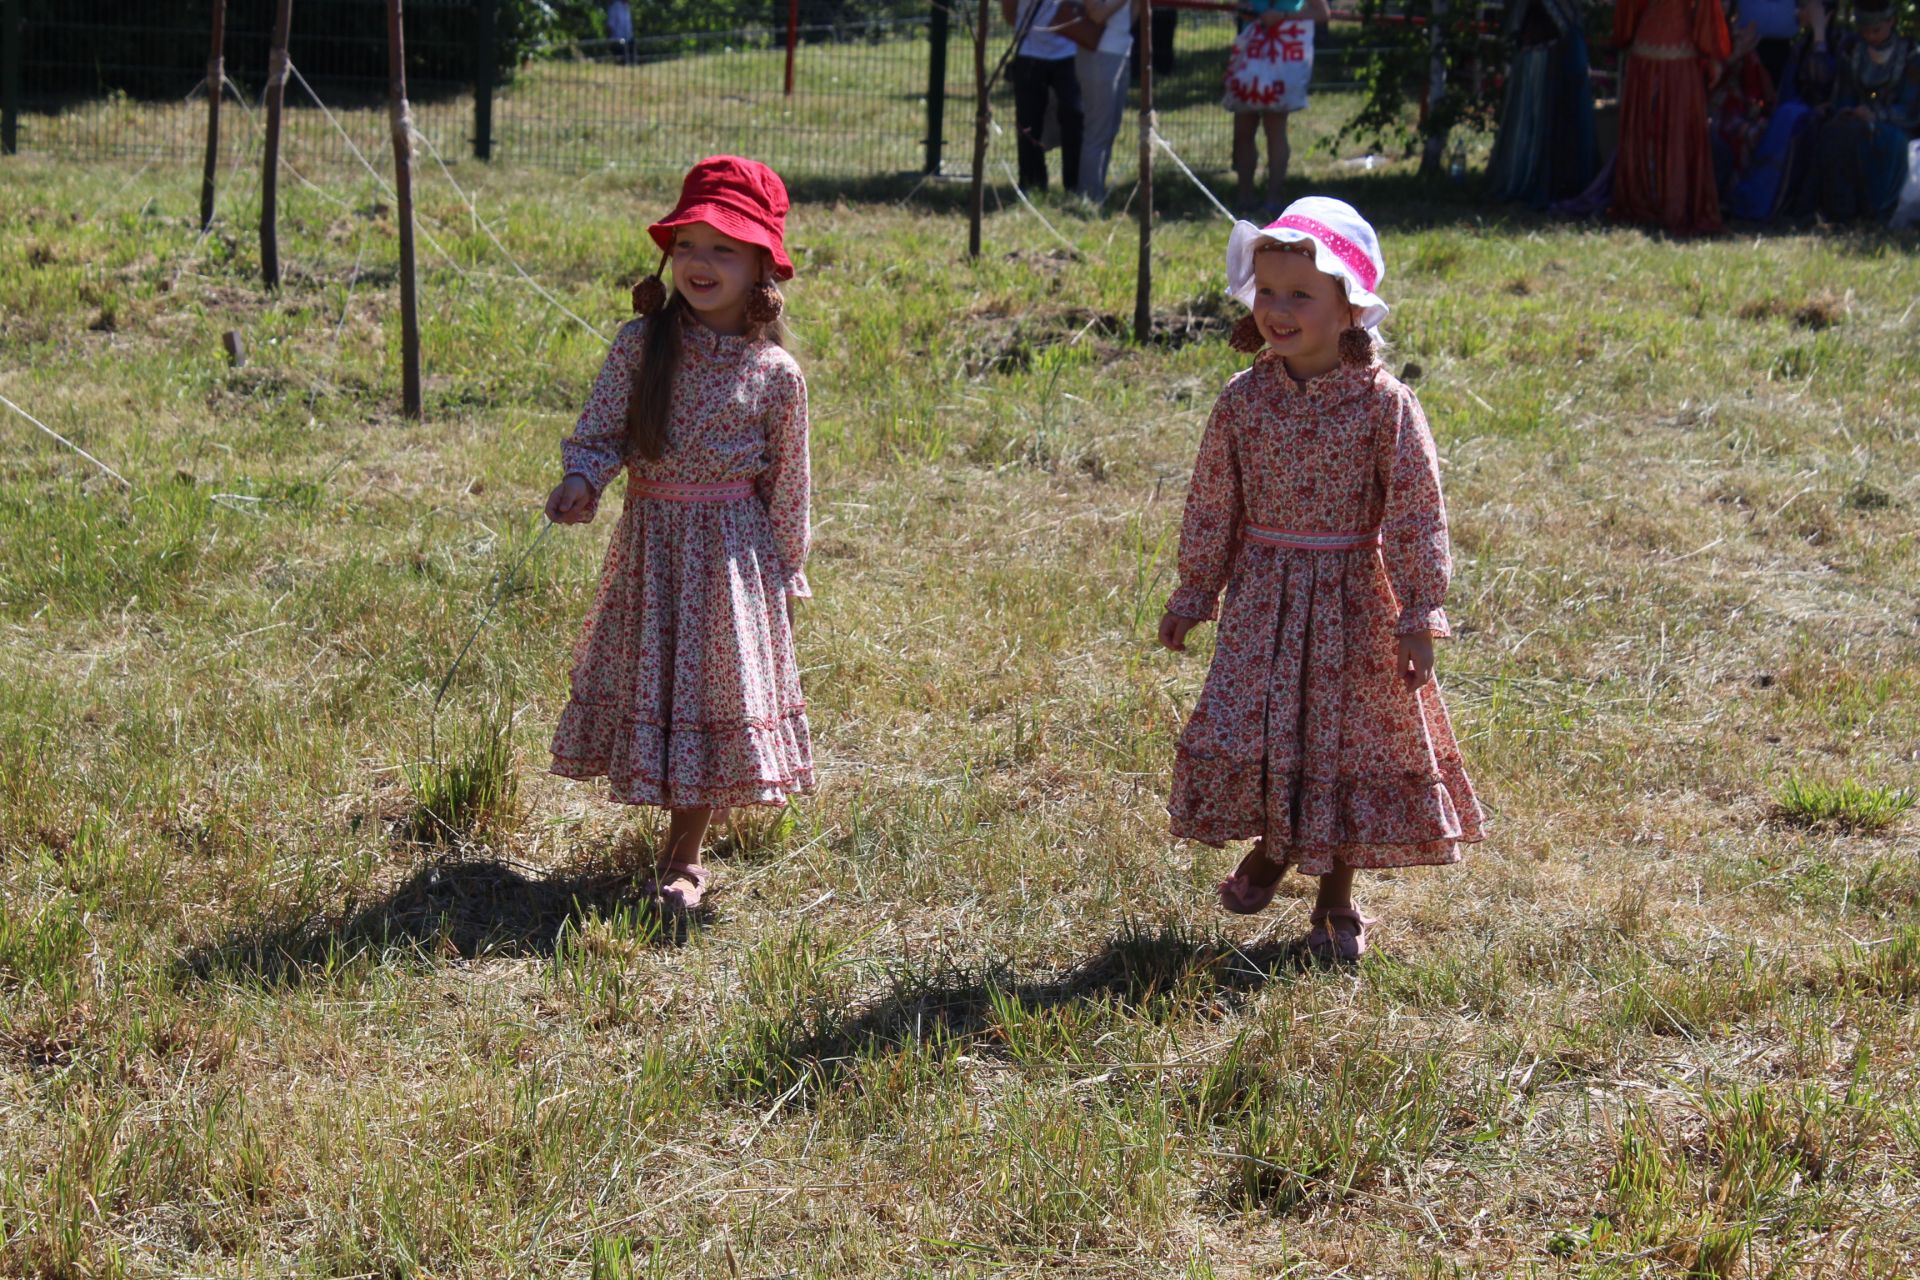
[1375,390,1453,635]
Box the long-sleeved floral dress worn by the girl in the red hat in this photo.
[553,317,814,808]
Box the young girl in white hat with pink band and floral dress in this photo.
[1160,196,1482,960]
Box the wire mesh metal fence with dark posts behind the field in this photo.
[0,0,1413,178]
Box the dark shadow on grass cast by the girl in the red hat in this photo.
[180,858,708,986]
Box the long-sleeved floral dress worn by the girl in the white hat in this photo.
[1167,351,1482,875]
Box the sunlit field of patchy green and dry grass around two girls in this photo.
[0,117,1920,1278]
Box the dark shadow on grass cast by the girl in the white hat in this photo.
[733,923,1311,1096]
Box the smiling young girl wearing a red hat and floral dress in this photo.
[547,155,814,910]
